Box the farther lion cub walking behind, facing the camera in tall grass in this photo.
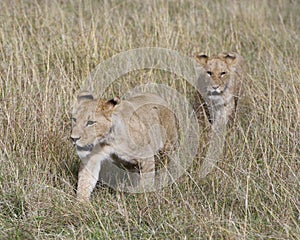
[196,53,246,121]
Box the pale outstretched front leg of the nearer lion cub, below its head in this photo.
[77,159,102,201]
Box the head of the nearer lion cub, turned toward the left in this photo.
[71,92,120,155]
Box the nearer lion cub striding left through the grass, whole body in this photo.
[71,92,177,200]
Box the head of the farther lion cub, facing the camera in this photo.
[196,53,238,95]
